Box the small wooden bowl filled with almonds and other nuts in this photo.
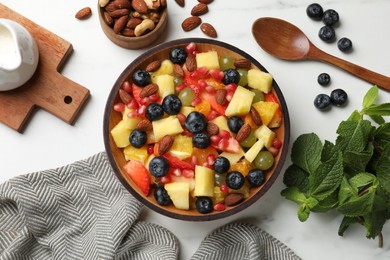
[98,0,168,49]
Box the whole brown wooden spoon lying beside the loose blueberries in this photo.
[252,17,390,90]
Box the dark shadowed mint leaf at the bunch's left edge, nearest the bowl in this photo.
[283,164,309,193]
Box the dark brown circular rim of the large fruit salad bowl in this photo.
[103,38,290,221]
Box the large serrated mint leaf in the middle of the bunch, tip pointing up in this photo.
[309,146,344,201]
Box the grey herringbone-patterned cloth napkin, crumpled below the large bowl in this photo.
[0,152,299,260]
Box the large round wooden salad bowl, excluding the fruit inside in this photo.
[103,38,290,221]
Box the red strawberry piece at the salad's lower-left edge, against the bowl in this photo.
[123,160,150,196]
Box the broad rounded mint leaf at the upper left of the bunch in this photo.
[291,133,322,174]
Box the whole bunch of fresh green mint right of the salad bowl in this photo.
[281,86,390,247]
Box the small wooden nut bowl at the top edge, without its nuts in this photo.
[98,4,168,49]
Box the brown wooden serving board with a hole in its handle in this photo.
[0,4,90,132]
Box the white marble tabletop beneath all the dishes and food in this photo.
[0,0,390,260]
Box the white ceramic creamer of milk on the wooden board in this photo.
[0,18,39,91]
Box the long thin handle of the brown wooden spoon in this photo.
[307,48,390,91]
